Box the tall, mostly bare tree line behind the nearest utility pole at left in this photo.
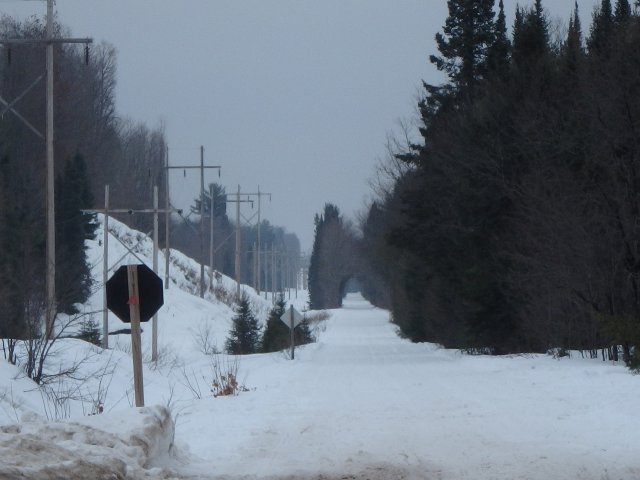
[0,16,166,362]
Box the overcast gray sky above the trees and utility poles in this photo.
[0,0,599,251]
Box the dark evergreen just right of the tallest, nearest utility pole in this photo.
[56,154,97,313]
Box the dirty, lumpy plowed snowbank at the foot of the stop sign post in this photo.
[0,407,175,480]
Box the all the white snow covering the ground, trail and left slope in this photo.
[0,221,640,480]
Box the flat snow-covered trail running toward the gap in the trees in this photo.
[177,297,640,480]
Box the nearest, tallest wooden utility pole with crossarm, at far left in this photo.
[0,0,93,339]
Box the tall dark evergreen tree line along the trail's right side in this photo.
[311,0,640,366]
